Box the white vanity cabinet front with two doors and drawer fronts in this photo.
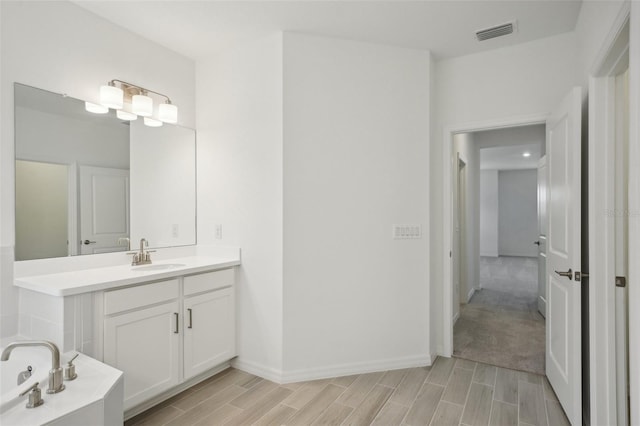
[99,268,236,410]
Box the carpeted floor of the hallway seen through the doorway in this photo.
[453,256,545,374]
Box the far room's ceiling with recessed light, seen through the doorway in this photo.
[480,143,541,170]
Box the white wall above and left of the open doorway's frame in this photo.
[430,33,579,352]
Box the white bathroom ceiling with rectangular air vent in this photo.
[75,0,581,60]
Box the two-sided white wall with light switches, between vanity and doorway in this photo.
[197,34,430,381]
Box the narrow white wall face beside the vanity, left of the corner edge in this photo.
[197,35,283,379]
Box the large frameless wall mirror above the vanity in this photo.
[14,83,196,261]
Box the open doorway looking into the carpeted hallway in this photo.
[453,124,545,375]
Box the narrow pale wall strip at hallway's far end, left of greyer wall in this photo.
[480,170,498,257]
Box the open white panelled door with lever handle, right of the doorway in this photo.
[546,88,582,425]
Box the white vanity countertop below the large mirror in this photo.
[14,254,240,296]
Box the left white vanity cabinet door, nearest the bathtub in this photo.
[104,301,181,410]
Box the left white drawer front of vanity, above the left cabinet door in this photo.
[104,279,180,315]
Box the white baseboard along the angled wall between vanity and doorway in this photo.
[232,354,434,384]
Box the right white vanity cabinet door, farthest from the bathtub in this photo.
[184,287,236,379]
